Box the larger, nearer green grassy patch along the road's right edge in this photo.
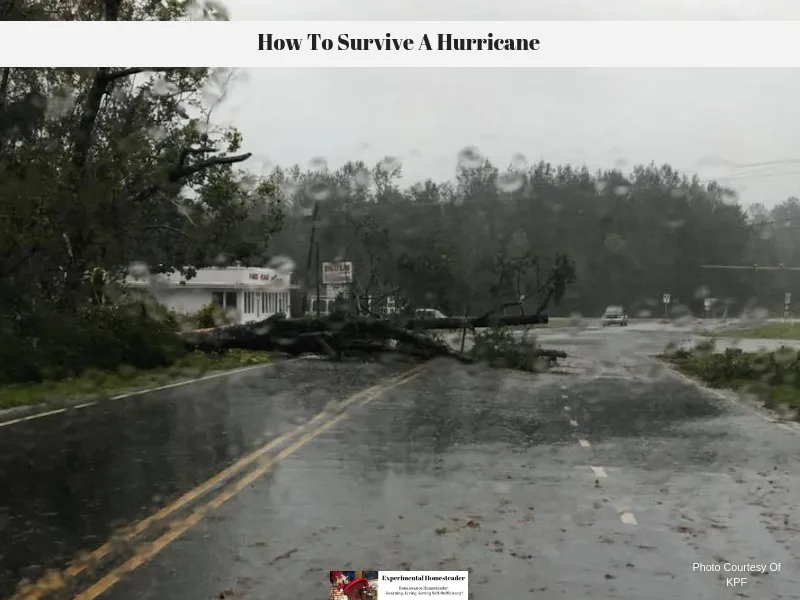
[662,344,800,418]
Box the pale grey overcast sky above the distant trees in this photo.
[212,0,800,205]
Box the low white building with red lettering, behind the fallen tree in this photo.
[126,267,291,323]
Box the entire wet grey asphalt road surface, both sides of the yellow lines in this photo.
[0,325,800,600]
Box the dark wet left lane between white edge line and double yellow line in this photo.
[0,361,407,597]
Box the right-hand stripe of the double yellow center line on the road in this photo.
[73,371,420,600]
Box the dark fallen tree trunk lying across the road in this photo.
[182,313,566,363]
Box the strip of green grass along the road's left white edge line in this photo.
[0,350,272,408]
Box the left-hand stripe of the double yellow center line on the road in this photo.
[12,365,424,600]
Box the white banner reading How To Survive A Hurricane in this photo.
[0,21,800,68]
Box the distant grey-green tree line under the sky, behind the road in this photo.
[272,157,800,317]
